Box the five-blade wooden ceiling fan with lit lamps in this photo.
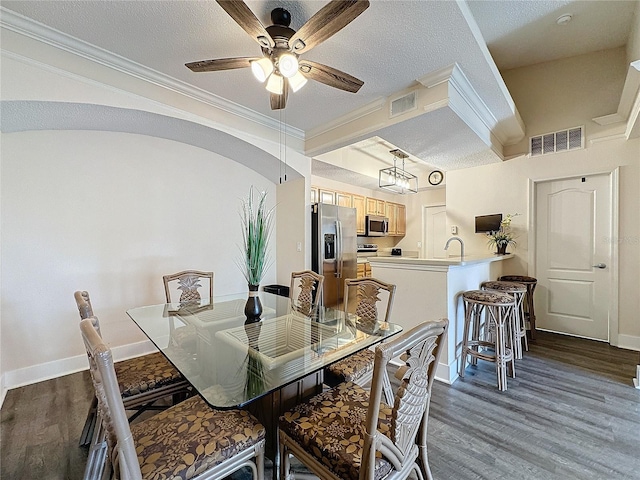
[185,0,369,110]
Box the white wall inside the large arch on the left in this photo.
[0,131,276,387]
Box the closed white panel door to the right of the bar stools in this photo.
[535,175,612,341]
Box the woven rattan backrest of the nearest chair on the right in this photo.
[360,319,449,480]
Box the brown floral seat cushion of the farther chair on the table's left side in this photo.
[115,352,183,398]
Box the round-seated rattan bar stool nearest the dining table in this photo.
[460,290,516,391]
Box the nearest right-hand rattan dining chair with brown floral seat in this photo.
[279,319,449,480]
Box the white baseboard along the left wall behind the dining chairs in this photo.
[0,340,156,400]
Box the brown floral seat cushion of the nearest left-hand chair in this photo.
[131,397,265,480]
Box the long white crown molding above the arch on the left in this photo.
[0,6,305,140]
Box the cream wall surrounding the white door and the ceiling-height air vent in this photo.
[447,48,640,349]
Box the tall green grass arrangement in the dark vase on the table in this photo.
[237,186,275,285]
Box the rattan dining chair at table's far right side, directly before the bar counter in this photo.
[324,277,396,386]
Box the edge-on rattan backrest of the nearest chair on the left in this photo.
[80,317,142,480]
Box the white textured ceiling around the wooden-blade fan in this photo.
[2,0,639,186]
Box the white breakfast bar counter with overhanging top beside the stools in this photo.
[369,254,513,383]
